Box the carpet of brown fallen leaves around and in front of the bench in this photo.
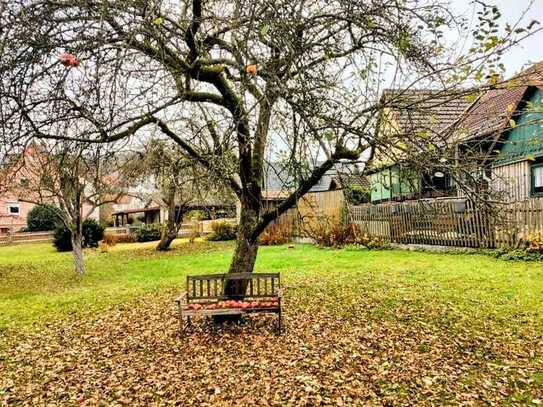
[0,282,543,406]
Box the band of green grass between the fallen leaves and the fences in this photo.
[0,241,543,329]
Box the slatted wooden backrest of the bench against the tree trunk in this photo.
[187,273,281,302]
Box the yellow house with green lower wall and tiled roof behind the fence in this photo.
[366,89,470,203]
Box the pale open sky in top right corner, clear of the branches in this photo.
[451,0,543,77]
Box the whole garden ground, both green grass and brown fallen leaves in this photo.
[0,241,543,405]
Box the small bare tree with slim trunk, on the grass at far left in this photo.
[19,141,131,275]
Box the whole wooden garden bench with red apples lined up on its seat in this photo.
[175,273,282,335]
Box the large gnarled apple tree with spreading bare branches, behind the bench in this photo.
[0,0,533,280]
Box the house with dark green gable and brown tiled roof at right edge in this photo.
[454,62,543,201]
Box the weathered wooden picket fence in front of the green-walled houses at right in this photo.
[349,198,543,248]
